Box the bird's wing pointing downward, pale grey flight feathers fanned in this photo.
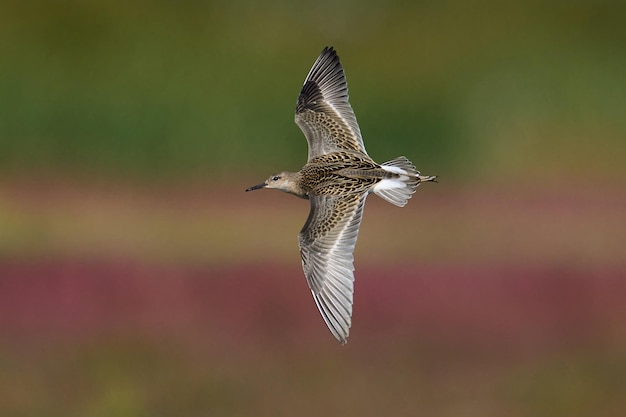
[298,193,367,345]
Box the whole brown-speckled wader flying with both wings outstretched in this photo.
[246,47,437,345]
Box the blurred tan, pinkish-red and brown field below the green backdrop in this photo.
[0,183,626,416]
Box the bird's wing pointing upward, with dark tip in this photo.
[296,47,366,161]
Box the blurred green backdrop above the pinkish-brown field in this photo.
[0,1,626,182]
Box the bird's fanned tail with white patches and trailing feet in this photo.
[372,156,437,207]
